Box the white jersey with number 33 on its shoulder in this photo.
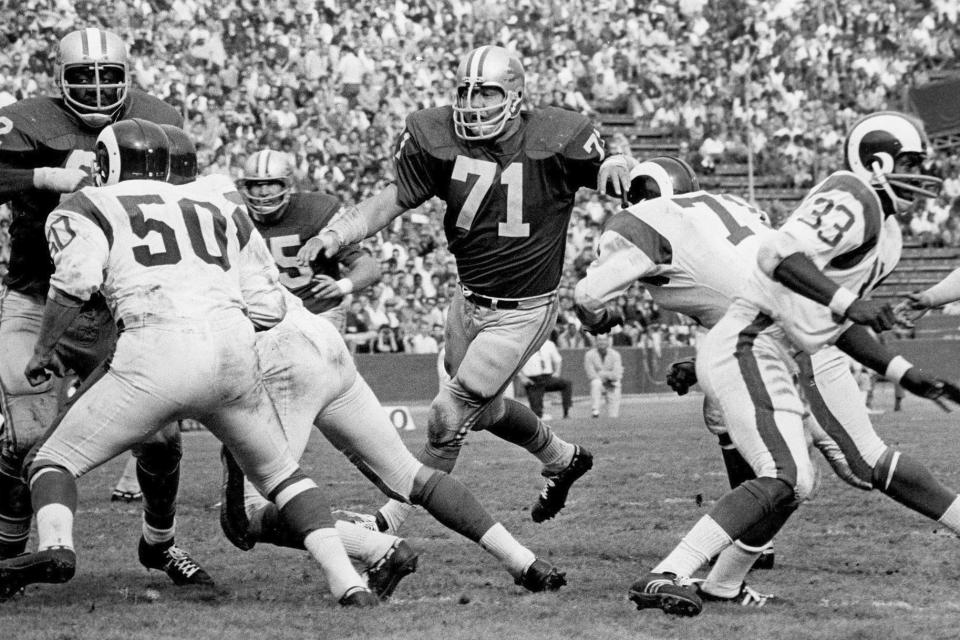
[740,171,903,353]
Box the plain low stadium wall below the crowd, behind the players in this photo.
[356,340,960,404]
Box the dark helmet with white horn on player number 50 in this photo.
[94,118,170,186]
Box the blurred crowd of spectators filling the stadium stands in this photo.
[0,0,960,352]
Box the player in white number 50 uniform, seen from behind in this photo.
[0,119,378,606]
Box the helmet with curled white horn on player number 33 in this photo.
[843,111,943,215]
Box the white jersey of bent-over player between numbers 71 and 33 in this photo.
[576,191,772,328]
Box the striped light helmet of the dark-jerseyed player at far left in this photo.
[53,28,130,129]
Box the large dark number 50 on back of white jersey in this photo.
[117,195,230,271]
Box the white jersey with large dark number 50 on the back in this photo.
[46,175,283,326]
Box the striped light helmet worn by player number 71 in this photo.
[453,45,524,140]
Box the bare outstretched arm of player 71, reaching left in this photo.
[297,184,406,267]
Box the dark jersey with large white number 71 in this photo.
[394,107,604,298]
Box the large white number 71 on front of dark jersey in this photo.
[450,156,530,238]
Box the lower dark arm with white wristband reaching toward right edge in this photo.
[836,325,960,409]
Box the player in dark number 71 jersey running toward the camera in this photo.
[298,46,631,531]
